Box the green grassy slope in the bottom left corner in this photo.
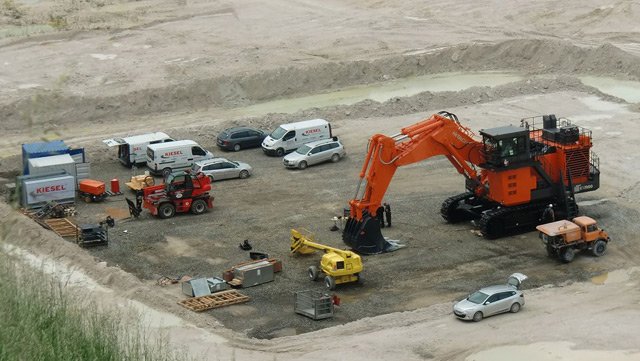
[0,252,188,361]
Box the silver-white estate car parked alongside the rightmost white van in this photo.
[282,137,347,169]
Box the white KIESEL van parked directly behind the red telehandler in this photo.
[147,140,213,175]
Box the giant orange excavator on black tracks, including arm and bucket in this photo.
[342,111,600,254]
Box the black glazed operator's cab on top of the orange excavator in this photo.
[480,125,531,168]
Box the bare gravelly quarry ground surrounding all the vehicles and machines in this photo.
[0,0,640,361]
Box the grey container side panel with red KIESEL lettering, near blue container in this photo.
[24,175,76,204]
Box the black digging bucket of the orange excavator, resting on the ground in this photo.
[342,213,395,254]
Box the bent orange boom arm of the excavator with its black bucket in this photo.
[343,112,484,254]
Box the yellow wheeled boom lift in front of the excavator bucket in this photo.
[291,229,362,290]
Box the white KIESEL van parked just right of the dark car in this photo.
[262,119,331,157]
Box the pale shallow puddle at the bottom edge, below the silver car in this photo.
[465,342,640,361]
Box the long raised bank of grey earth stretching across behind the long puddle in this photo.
[0,40,640,130]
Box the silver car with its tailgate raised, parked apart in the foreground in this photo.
[453,273,527,322]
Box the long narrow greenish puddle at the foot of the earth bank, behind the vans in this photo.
[236,72,522,116]
